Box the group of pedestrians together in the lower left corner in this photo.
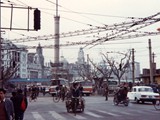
[0,88,28,120]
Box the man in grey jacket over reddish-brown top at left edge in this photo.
[0,88,14,120]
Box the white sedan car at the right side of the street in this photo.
[127,86,160,104]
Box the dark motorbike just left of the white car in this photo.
[113,93,129,106]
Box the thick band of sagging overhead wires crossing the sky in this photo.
[10,12,160,49]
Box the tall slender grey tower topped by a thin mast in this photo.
[54,0,60,79]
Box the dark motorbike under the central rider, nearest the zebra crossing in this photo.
[65,97,85,114]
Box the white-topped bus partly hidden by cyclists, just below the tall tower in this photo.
[49,78,69,96]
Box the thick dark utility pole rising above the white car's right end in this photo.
[148,39,153,84]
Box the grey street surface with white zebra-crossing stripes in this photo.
[24,95,160,120]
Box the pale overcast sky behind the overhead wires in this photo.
[1,0,160,69]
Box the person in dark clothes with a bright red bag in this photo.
[14,89,28,120]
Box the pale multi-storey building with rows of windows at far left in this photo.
[2,41,28,78]
